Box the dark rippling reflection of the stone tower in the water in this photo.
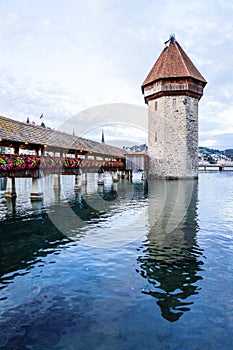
[137,180,203,322]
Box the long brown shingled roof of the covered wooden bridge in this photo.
[0,116,124,158]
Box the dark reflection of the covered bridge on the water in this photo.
[0,174,144,282]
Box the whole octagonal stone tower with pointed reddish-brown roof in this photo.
[142,35,206,179]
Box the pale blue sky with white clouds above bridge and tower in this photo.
[0,0,233,149]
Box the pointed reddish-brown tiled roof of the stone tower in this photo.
[142,37,206,88]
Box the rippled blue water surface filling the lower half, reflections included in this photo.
[0,172,233,350]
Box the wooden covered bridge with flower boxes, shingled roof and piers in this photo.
[0,117,125,199]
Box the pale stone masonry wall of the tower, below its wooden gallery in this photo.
[148,95,198,178]
